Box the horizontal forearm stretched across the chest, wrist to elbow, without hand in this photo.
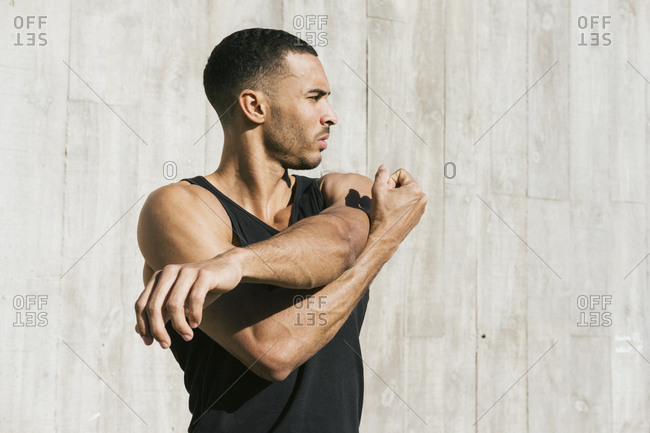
[226,208,369,289]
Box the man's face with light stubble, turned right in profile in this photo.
[264,52,337,170]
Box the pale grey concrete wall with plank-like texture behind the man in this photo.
[0,0,650,433]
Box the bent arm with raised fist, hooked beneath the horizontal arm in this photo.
[200,169,427,381]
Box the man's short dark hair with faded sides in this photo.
[203,28,318,126]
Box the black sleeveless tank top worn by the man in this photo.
[166,175,369,433]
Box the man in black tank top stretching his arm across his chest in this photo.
[136,29,427,432]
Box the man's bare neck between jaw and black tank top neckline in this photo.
[209,133,293,221]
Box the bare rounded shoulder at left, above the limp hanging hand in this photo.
[138,182,232,270]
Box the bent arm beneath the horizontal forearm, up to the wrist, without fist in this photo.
[202,228,399,380]
